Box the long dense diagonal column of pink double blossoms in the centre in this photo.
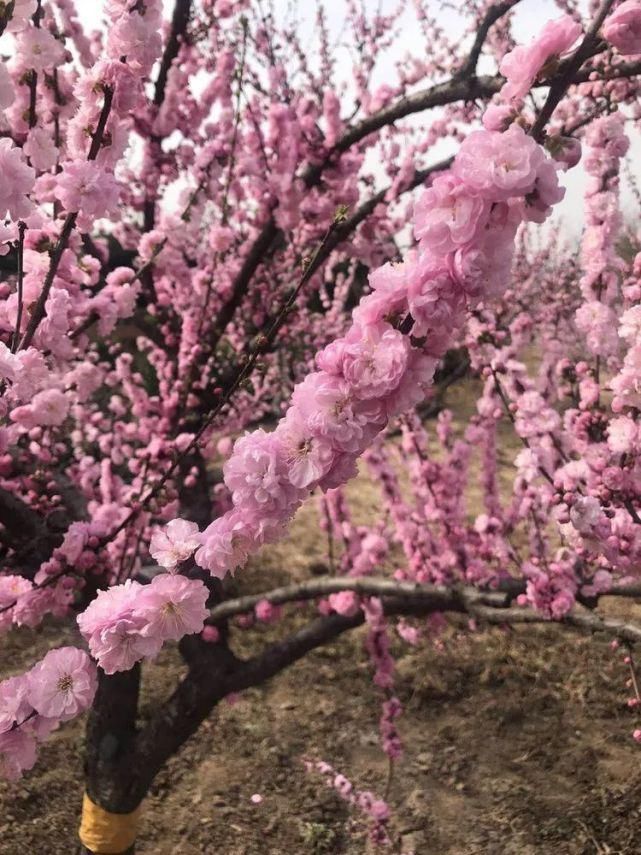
[184,118,563,578]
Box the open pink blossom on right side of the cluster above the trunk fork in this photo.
[136,573,209,643]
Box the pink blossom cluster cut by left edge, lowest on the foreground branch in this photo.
[0,647,97,781]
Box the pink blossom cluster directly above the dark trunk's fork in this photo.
[78,573,209,674]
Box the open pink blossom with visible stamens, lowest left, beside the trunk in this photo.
[27,647,98,721]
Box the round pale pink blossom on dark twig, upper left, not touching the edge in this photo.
[55,160,119,218]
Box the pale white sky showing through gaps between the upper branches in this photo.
[76,0,641,237]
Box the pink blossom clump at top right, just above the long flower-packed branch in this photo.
[499,15,581,99]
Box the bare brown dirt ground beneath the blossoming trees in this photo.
[0,390,641,855]
